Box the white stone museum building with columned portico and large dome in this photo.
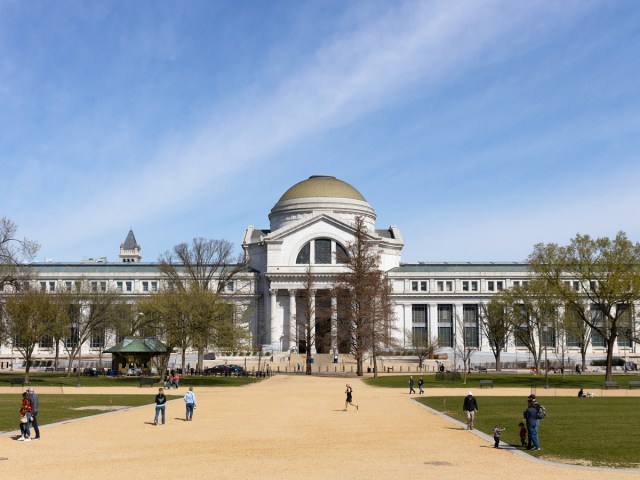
[0,175,636,367]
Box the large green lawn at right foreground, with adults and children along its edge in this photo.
[416,394,640,468]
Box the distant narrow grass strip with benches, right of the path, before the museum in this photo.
[367,373,640,394]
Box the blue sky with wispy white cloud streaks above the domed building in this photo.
[0,0,640,263]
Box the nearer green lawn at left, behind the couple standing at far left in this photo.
[0,390,181,432]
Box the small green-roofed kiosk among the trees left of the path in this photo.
[104,337,170,374]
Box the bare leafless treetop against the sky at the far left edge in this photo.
[0,217,40,292]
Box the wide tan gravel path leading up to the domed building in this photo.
[0,375,640,480]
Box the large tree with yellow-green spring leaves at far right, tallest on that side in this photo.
[529,232,640,381]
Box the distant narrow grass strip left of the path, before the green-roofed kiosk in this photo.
[0,372,260,392]
